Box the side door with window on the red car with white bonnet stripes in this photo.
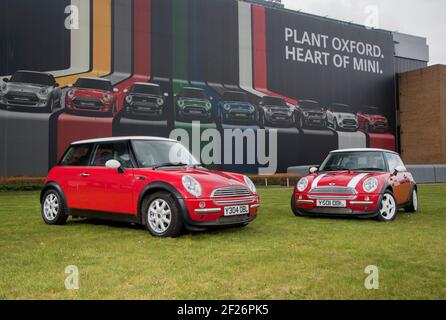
[385,152,410,204]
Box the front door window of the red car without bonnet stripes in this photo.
[92,142,133,168]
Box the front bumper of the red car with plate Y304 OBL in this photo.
[178,195,260,230]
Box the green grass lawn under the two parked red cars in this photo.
[0,185,446,299]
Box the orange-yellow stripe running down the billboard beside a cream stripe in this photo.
[57,0,112,87]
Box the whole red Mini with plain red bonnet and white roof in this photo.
[40,137,260,237]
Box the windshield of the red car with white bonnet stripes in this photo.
[320,151,386,172]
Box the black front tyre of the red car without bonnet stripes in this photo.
[141,192,184,238]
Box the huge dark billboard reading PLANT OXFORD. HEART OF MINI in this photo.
[0,0,396,176]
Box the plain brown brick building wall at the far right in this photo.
[399,65,446,164]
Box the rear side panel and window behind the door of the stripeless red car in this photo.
[58,144,93,209]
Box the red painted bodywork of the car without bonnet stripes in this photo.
[41,137,260,236]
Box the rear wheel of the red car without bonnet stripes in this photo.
[40,189,68,225]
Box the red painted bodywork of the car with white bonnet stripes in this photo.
[292,149,418,218]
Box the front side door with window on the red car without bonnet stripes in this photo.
[85,141,134,214]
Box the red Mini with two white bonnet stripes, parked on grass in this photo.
[291,149,418,221]
